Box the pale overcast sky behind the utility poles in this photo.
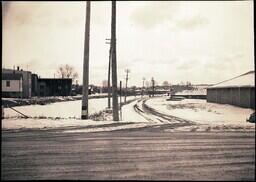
[2,1,254,86]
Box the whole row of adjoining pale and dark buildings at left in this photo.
[2,66,72,98]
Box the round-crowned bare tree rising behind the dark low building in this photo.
[57,64,78,81]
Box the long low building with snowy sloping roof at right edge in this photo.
[207,71,255,109]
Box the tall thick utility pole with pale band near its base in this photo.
[81,1,91,119]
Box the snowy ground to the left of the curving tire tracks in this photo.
[2,96,152,132]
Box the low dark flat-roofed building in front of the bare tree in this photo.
[37,78,72,97]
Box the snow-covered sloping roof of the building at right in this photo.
[208,71,255,89]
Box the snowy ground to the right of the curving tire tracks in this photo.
[146,97,255,126]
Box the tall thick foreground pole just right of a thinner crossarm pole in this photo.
[111,1,119,121]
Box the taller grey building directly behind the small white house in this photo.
[2,66,31,98]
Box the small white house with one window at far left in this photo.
[2,73,23,98]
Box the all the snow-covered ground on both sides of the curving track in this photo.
[2,96,255,132]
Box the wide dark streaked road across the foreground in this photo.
[1,128,255,180]
